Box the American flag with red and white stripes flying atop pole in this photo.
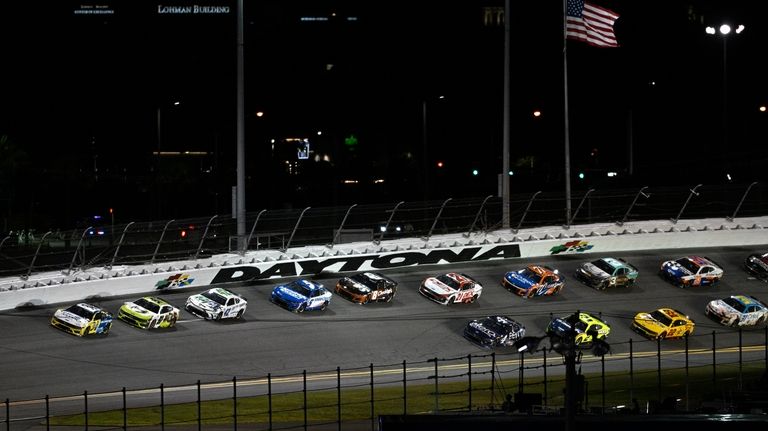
[565,0,619,48]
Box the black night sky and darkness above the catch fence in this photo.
[0,0,768,230]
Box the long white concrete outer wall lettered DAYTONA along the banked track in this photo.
[0,218,768,310]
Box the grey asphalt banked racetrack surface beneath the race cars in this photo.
[0,245,768,416]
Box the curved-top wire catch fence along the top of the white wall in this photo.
[0,183,768,278]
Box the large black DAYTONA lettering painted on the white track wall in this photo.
[210,244,520,284]
